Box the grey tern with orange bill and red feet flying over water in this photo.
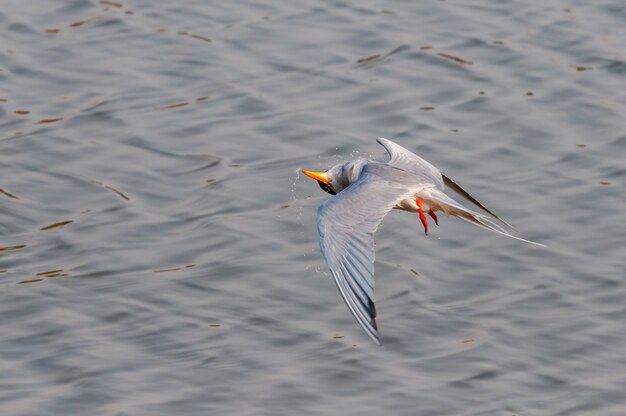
[302,138,545,345]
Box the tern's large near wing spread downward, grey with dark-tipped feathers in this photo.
[317,169,414,344]
